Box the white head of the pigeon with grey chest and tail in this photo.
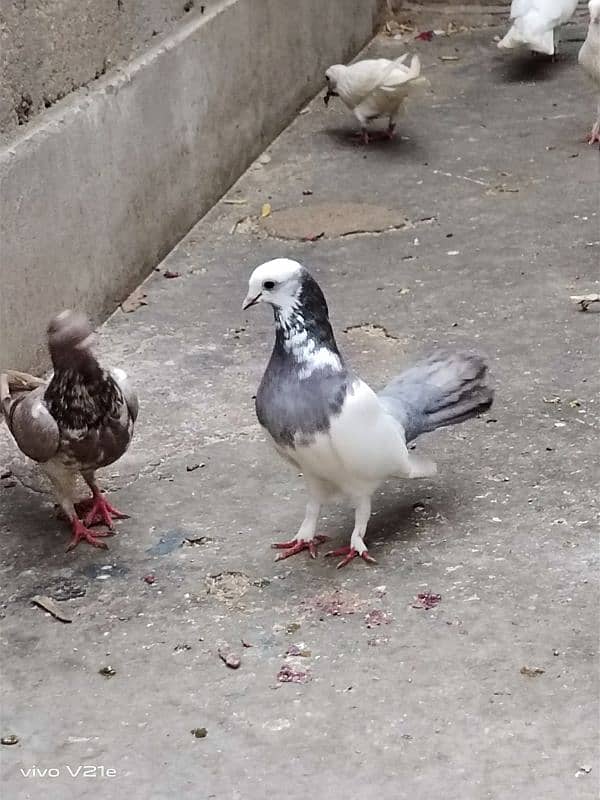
[242,258,306,316]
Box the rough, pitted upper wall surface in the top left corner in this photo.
[0,0,216,141]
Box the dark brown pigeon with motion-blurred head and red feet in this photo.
[0,311,138,550]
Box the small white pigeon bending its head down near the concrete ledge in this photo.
[323,53,429,144]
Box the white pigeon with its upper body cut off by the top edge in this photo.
[498,0,578,56]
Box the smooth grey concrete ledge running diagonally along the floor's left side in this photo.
[0,0,381,370]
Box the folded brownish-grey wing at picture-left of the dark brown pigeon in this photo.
[2,386,60,463]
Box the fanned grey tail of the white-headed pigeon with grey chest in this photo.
[378,350,494,442]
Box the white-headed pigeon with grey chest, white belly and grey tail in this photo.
[243,258,493,567]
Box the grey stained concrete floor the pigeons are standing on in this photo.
[0,18,600,800]
